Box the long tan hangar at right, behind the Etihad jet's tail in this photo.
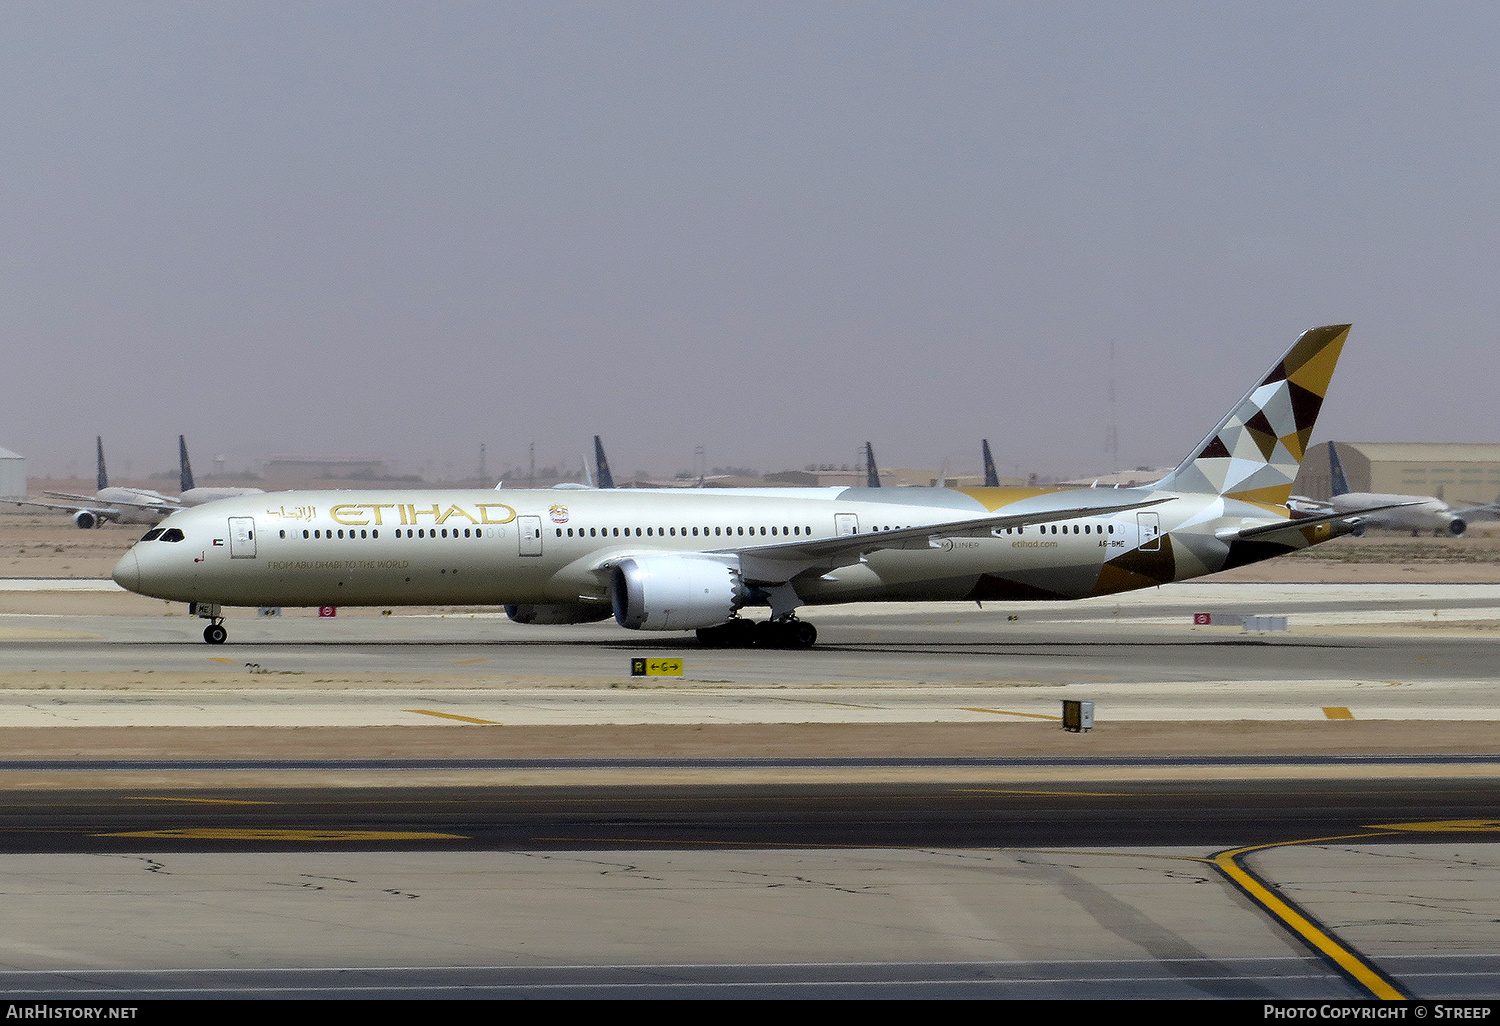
[1293,441,1500,506]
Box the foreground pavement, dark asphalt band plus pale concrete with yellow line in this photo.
[0,780,1500,999]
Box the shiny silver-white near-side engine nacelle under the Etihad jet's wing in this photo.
[609,555,747,630]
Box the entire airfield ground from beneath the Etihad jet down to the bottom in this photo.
[0,585,1500,999]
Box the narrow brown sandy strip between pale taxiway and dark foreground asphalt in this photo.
[0,720,1500,759]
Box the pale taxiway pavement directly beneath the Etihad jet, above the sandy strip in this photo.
[0,585,1500,728]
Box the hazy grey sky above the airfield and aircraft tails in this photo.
[0,0,1500,474]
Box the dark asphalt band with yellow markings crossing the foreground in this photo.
[0,779,1500,854]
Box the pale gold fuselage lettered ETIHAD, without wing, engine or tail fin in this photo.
[114,489,1278,609]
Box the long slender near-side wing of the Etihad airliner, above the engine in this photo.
[714,497,1173,584]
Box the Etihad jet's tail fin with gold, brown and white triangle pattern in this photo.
[1157,324,1350,506]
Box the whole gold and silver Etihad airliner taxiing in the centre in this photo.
[114,324,1392,647]
